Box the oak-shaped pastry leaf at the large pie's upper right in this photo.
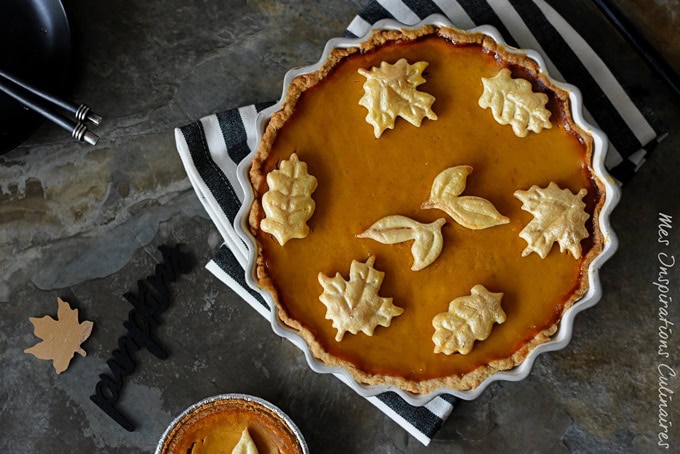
[479,68,552,137]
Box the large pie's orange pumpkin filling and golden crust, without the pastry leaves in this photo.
[249,26,604,394]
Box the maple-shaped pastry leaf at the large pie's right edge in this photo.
[514,181,590,259]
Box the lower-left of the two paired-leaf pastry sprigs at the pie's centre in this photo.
[357,215,446,271]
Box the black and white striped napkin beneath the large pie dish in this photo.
[175,0,664,445]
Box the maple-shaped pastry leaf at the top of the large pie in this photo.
[359,58,437,139]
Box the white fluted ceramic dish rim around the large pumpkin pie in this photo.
[234,15,620,406]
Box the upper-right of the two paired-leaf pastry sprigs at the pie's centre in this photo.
[421,165,510,230]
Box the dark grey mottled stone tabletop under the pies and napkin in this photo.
[0,0,680,453]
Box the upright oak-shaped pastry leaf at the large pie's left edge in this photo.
[260,153,317,246]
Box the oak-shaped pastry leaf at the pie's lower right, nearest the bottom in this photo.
[432,285,505,355]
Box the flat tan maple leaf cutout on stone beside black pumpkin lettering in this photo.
[24,298,94,374]
